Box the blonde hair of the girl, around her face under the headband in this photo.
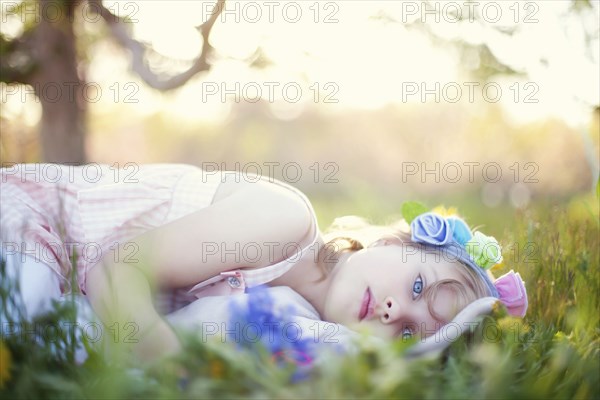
[318,215,491,323]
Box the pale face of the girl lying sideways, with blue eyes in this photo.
[323,245,465,338]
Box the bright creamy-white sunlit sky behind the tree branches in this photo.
[2,0,600,126]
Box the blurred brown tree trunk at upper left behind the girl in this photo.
[31,0,86,164]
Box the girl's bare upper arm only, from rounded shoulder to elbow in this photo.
[131,181,312,287]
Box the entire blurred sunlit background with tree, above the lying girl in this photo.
[0,0,600,236]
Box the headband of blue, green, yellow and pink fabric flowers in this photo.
[402,202,528,317]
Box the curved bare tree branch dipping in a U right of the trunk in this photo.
[88,0,225,91]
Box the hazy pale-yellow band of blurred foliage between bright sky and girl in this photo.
[0,101,600,193]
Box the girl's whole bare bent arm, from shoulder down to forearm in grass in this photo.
[87,177,312,360]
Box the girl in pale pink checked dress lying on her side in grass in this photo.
[0,164,527,360]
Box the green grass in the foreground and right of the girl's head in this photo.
[0,196,600,399]
